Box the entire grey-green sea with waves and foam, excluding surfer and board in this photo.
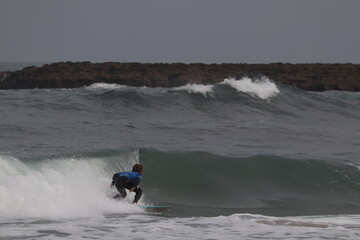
[0,64,360,239]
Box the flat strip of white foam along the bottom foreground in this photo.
[0,214,360,240]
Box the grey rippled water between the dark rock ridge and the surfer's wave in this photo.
[0,80,360,161]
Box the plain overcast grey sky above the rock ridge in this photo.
[0,0,360,63]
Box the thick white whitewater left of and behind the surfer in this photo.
[0,156,142,219]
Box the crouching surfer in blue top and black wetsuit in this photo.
[110,163,143,203]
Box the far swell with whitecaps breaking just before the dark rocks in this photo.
[0,77,360,119]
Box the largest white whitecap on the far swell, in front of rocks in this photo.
[221,77,280,99]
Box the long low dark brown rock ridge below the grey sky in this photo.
[0,62,360,91]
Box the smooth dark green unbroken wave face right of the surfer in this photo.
[140,149,360,215]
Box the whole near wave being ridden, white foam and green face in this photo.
[0,149,360,218]
